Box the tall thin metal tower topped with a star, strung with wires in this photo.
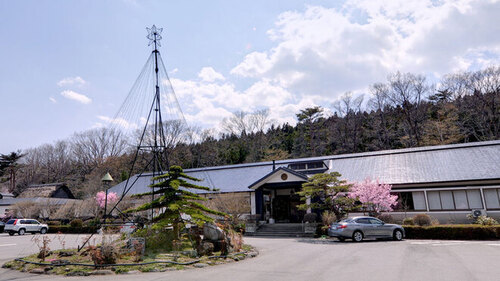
[82,25,187,247]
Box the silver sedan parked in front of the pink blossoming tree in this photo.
[328,217,405,242]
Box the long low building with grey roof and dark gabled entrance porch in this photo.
[111,140,500,223]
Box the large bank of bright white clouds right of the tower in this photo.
[146,0,500,133]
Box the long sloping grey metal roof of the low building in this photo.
[110,140,500,194]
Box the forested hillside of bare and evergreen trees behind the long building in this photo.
[0,66,500,197]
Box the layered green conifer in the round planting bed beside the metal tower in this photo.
[127,166,226,238]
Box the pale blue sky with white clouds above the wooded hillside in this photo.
[0,0,500,153]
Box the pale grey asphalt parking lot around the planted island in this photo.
[0,234,500,280]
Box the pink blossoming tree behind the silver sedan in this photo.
[349,178,398,214]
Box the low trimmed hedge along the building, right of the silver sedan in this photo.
[403,224,500,240]
